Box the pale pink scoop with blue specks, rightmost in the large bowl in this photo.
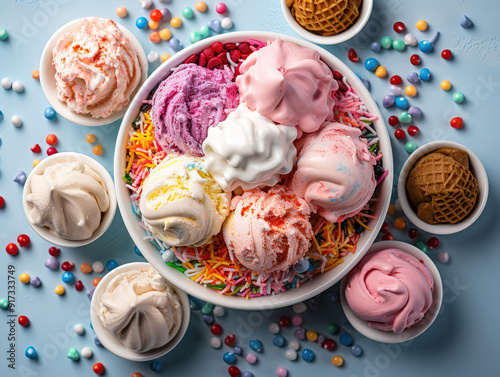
[287,122,376,223]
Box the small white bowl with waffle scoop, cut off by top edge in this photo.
[281,0,373,45]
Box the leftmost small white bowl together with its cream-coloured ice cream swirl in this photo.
[23,152,116,247]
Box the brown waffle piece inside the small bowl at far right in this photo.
[406,148,479,224]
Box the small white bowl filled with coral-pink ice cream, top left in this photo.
[40,17,148,126]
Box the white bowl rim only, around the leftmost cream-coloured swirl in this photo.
[23,152,117,247]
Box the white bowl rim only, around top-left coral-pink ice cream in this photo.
[40,18,148,126]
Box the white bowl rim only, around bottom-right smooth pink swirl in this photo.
[340,241,443,343]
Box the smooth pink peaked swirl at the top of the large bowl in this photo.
[236,39,338,136]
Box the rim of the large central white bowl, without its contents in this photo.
[114,31,393,310]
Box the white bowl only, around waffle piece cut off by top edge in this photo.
[281,0,373,45]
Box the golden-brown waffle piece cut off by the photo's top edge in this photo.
[291,0,362,36]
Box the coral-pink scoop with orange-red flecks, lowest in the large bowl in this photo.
[223,185,313,273]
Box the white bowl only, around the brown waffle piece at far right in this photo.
[398,140,489,234]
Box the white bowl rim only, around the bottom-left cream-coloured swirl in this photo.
[90,262,191,361]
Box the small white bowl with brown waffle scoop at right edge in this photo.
[398,141,488,234]
